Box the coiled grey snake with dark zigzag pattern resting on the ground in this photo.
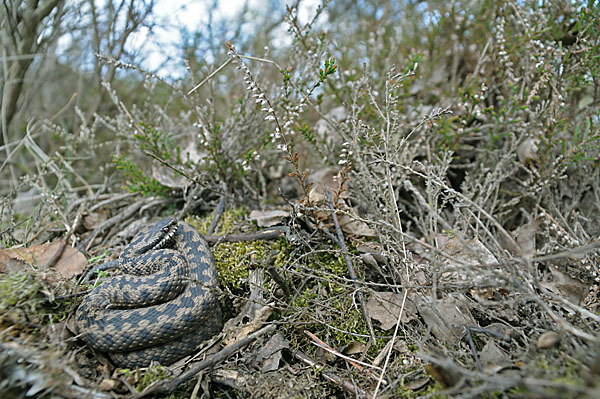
[75,218,222,368]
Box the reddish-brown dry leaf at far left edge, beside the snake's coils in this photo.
[0,241,87,279]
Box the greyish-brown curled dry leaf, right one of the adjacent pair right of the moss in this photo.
[417,294,476,345]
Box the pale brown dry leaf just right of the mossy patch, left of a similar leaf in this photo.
[367,292,417,330]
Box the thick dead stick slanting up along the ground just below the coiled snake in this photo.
[135,324,275,398]
